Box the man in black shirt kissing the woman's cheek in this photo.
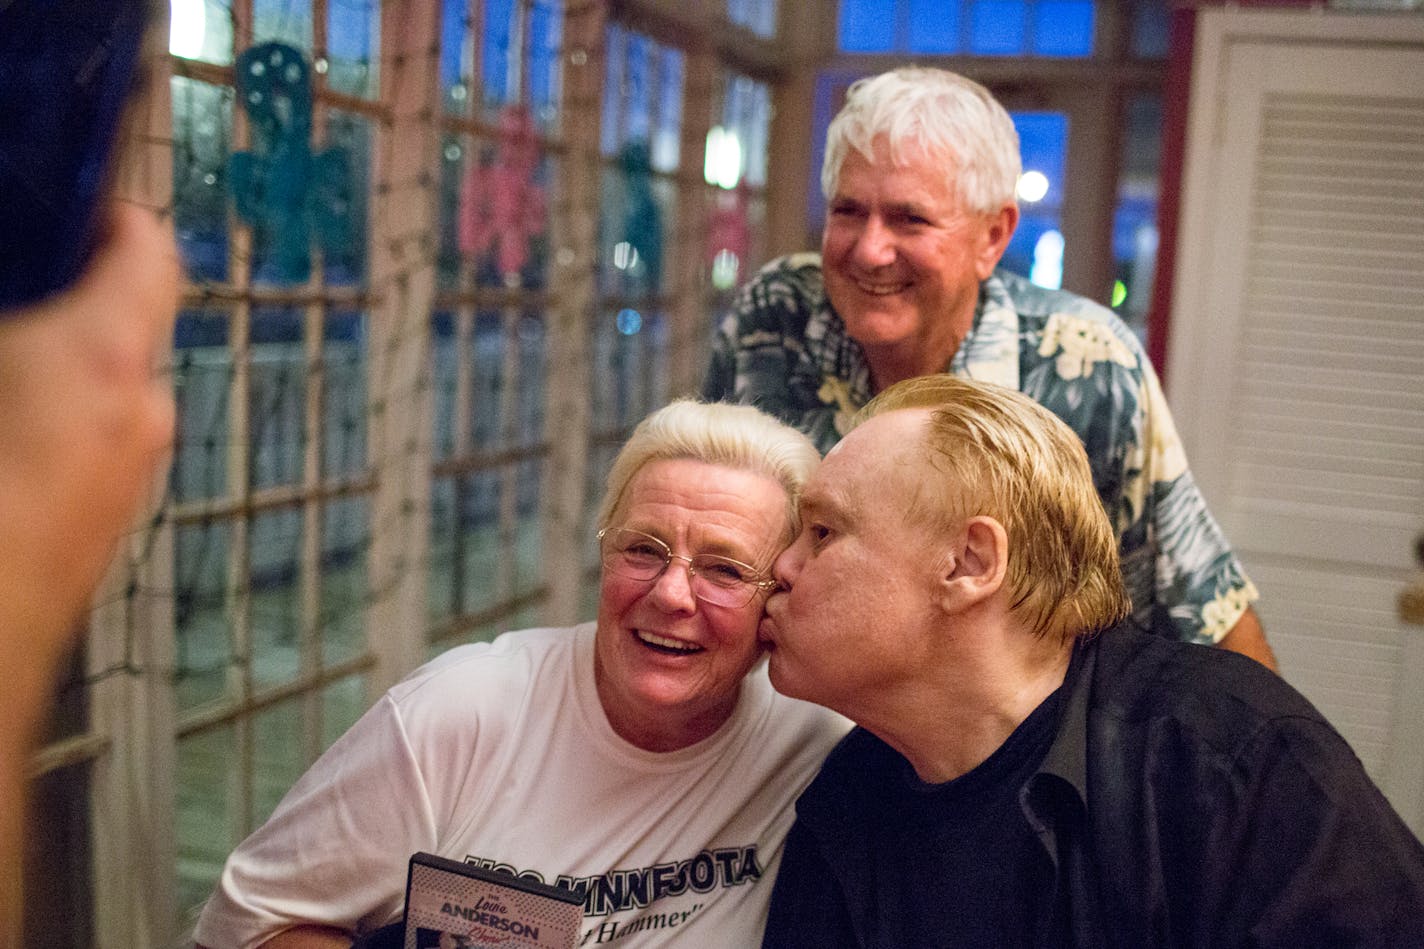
[762,376,1424,949]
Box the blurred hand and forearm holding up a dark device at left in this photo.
[0,204,179,919]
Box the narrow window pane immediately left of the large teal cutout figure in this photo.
[171,76,234,281]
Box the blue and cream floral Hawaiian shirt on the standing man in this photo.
[702,254,1257,643]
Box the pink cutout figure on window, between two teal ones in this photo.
[460,104,545,279]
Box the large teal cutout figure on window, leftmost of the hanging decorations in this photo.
[229,43,352,284]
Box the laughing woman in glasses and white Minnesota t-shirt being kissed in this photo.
[197,402,849,949]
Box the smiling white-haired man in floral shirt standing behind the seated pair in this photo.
[702,67,1276,668]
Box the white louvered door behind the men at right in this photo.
[1169,11,1424,829]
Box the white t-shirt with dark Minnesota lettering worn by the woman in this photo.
[195,623,850,949]
